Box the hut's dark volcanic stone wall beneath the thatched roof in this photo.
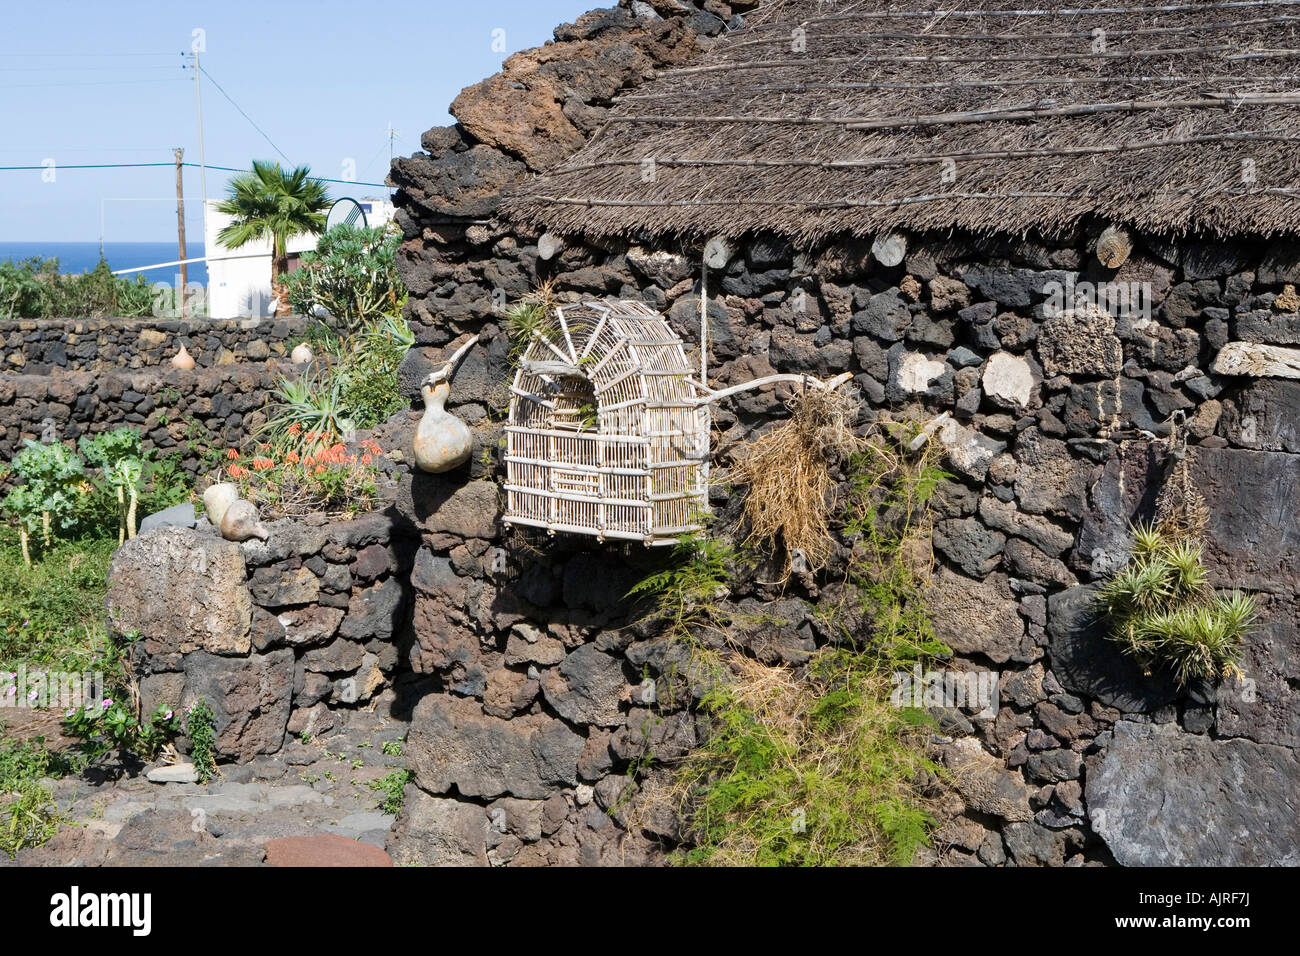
[379,214,1300,865]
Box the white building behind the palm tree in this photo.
[203,199,395,319]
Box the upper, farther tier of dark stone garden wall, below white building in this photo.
[0,316,309,375]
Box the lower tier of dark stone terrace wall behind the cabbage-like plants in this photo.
[0,362,291,473]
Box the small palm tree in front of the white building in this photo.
[217,160,330,315]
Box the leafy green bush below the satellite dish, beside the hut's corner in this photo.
[285,225,406,336]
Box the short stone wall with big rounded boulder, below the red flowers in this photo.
[116,514,415,762]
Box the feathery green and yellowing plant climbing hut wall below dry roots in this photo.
[631,436,950,866]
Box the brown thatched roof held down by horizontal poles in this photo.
[506,0,1300,242]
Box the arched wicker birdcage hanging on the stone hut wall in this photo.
[504,300,710,545]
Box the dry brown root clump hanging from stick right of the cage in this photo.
[731,388,863,578]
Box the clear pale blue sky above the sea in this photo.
[0,0,595,242]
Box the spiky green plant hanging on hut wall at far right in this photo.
[1100,524,1258,685]
